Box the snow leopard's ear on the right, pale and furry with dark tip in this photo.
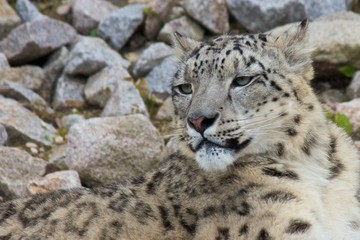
[269,19,313,78]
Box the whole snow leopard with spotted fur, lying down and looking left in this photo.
[0,22,360,240]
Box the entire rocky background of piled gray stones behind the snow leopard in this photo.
[0,0,360,201]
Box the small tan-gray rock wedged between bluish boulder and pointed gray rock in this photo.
[84,66,130,107]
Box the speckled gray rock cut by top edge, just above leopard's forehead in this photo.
[185,0,230,34]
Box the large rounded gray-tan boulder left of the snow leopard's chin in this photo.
[65,114,164,186]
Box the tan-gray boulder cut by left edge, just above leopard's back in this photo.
[0,147,46,200]
